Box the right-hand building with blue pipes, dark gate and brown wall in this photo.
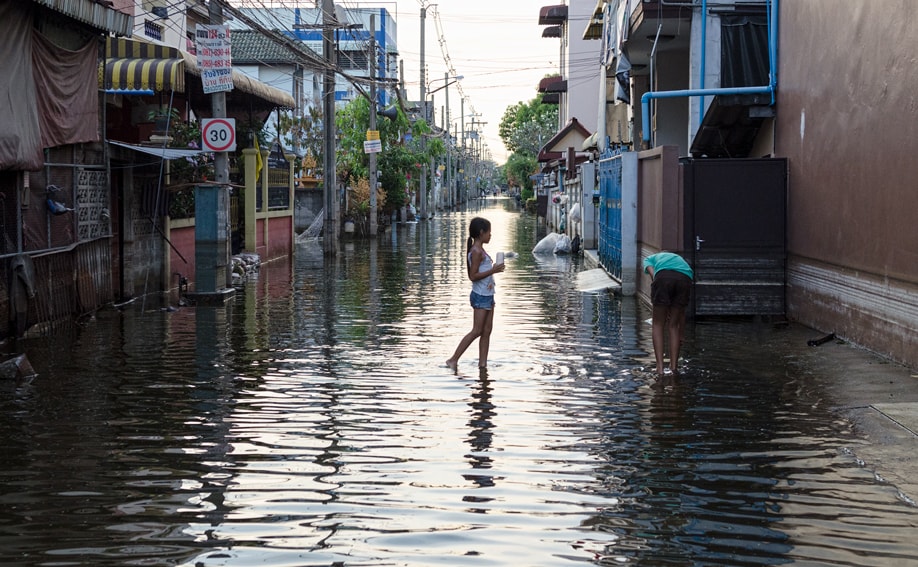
[582,0,918,365]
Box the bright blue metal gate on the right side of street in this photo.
[598,149,622,281]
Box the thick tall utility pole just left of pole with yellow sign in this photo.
[324,0,338,256]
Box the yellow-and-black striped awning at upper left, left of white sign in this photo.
[99,38,185,94]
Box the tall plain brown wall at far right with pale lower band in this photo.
[775,0,918,366]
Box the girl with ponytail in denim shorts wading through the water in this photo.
[446,217,504,370]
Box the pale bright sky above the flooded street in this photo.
[362,0,561,164]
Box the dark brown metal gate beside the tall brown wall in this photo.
[683,159,787,315]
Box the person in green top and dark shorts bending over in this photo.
[644,252,695,375]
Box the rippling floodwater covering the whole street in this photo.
[0,199,918,567]
